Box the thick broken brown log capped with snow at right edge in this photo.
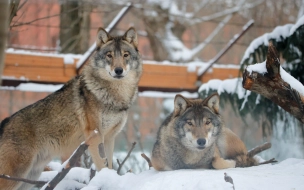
[242,43,304,123]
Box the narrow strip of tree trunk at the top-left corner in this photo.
[0,0,9,85]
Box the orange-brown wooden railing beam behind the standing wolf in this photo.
[3,53,239,91]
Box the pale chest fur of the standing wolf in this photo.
[80,71,137,134]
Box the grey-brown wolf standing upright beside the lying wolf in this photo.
[0,28,142,190]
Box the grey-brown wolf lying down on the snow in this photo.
[151,94,257,170]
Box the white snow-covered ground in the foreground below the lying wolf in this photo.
[39,158,304,190]
